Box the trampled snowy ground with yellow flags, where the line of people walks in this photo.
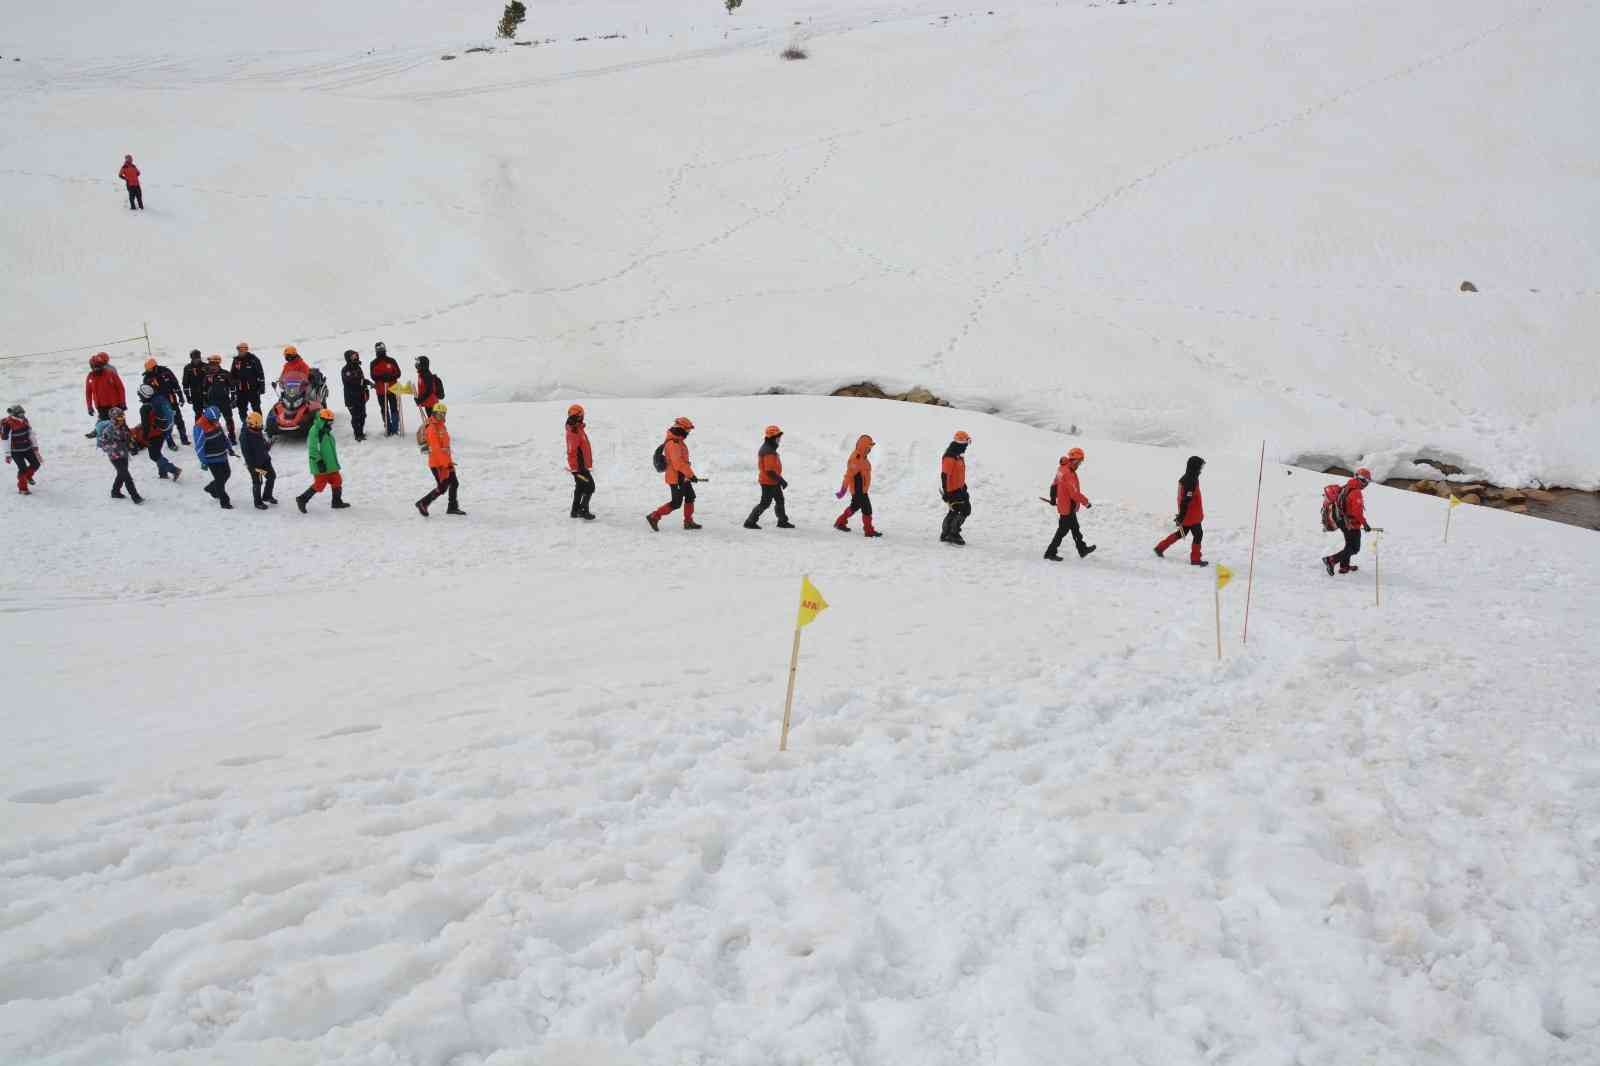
[0,397,1600,1066]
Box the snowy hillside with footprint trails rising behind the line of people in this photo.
[0,0,1600,487]
